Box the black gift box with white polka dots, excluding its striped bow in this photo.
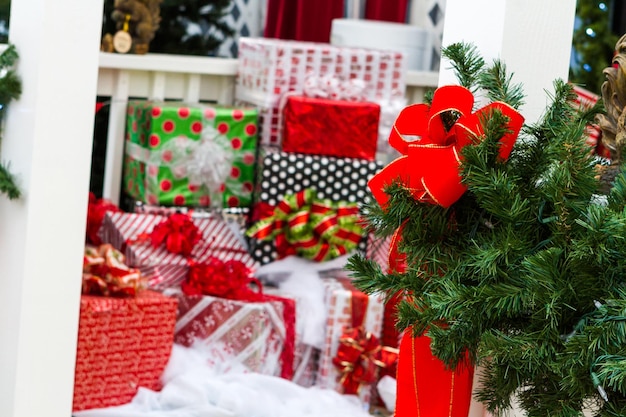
[249,150,383,264]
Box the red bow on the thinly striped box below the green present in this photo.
[146,213,202,257]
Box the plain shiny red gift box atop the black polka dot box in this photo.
[282,96,380,161]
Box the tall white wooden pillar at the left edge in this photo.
[0,0,103,417]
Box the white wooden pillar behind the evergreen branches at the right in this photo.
[439,0,576,123]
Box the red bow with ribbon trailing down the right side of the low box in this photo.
[181,258,296,379]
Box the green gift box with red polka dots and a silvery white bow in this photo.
[123,100,258,208]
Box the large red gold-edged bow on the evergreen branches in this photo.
[369,86,524,208]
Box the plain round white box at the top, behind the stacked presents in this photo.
[330,19,432,71]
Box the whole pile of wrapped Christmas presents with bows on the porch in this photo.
[74,38,405,410]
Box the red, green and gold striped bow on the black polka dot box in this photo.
[246,188,364,262]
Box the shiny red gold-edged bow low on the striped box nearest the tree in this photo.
[333,327,398,394]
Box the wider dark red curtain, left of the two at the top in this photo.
[264,0,344,43]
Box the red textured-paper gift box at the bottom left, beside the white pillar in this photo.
[72,290,177,411]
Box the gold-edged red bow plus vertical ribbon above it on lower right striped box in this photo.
[333,279,398,394]
